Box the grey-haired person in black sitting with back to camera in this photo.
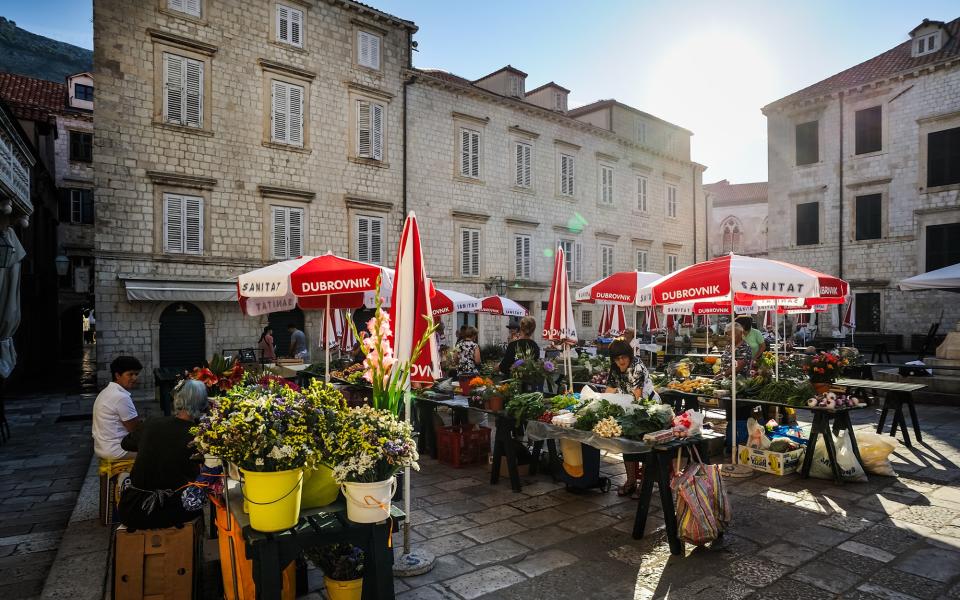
[119,379,207,529]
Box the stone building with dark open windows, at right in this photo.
[763,19,960,345]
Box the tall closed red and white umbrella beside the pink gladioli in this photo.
[390,211,440,575]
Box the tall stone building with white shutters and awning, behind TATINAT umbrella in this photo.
[94,0,416,381]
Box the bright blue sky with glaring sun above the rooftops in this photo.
[0,0,960,183]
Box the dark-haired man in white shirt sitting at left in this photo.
[93,356,143,459]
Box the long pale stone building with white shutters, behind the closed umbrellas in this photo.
[407,72,705,343]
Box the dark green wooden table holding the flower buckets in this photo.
[225,479,405,600]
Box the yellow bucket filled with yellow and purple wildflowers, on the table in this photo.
[191,382,335,532]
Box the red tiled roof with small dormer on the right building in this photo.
[763,18,960,111]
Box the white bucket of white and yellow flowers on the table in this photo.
[324,406,420,523]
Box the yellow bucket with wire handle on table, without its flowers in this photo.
[240,469,303,533]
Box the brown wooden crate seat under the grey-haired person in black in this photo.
[113,518,203,600]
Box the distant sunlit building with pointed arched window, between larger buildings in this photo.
[703,179,767,258]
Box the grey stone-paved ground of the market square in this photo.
[0,393,960,600]
